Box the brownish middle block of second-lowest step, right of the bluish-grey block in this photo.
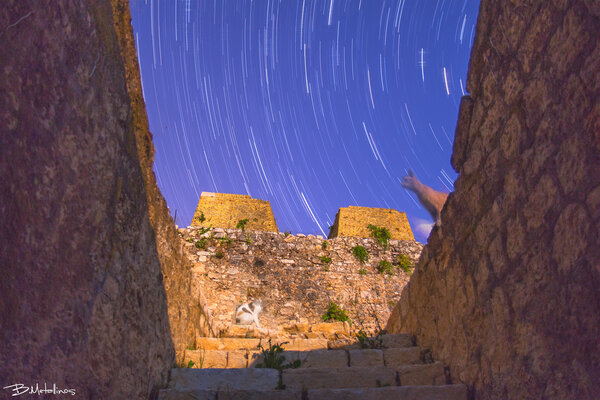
[282,367,396,390]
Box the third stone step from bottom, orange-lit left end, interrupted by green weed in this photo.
[184,347,423,368]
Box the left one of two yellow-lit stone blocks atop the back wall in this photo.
[190,192,279,232]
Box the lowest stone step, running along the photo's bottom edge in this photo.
[158,385,467,400]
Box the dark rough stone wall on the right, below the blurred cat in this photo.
[388,0,600,399]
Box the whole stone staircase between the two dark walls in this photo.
[158,324,467,400]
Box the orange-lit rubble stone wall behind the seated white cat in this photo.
[179,227,422,333]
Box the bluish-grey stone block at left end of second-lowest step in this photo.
[169,368,279,390]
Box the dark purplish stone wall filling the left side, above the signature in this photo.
[0,0,174,399]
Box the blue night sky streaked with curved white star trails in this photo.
[131,0,479,242]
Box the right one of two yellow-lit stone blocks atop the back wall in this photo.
[329,206,415,240]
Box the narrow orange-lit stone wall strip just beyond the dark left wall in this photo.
[111,0,214,350]
